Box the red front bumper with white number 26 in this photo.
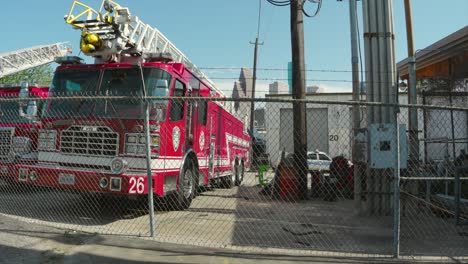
[16,164,162,195]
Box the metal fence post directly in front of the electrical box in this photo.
[393,119,400,258]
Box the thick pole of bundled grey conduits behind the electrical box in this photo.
[362,0,398,215]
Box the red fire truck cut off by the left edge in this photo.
[0,83,49,182]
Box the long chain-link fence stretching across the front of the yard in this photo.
[0,93,468,258]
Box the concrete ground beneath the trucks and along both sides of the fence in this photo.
[0,174,468,264]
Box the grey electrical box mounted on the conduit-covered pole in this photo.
[369,124,408,169]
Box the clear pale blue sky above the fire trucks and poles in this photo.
[0,0,468,95]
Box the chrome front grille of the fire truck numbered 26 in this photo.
[60,126,119,156]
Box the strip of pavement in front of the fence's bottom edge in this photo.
[0,212,468,264]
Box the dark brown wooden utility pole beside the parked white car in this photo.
[290,0,307,199]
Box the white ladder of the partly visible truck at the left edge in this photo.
[0,42,71,78]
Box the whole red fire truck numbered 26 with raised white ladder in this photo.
[18,1,250,208]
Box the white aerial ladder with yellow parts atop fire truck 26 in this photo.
[65,0,224,96]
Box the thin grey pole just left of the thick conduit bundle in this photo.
[349,0,363,212]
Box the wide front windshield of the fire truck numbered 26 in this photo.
[45,67,171,119]
